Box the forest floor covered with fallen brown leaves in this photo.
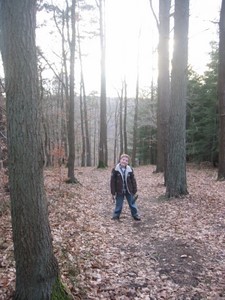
[0,166,225,300]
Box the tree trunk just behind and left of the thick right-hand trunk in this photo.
[156,0,171,173]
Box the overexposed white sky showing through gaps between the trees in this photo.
[34,0,221,96]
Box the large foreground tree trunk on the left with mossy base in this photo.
[0,0,68,300]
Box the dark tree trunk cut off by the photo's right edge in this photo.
[218,0,225,180]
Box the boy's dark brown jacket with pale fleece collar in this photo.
[110,164,137,195]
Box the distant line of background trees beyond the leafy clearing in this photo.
[0,42,219,167]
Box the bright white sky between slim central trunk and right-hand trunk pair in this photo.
[106,0,157,95]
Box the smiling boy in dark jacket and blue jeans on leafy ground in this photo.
[110,154,141,221]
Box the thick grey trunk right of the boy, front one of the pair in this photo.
[166,0,189,198]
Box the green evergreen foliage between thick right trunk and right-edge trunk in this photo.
[187,43,219,163]
